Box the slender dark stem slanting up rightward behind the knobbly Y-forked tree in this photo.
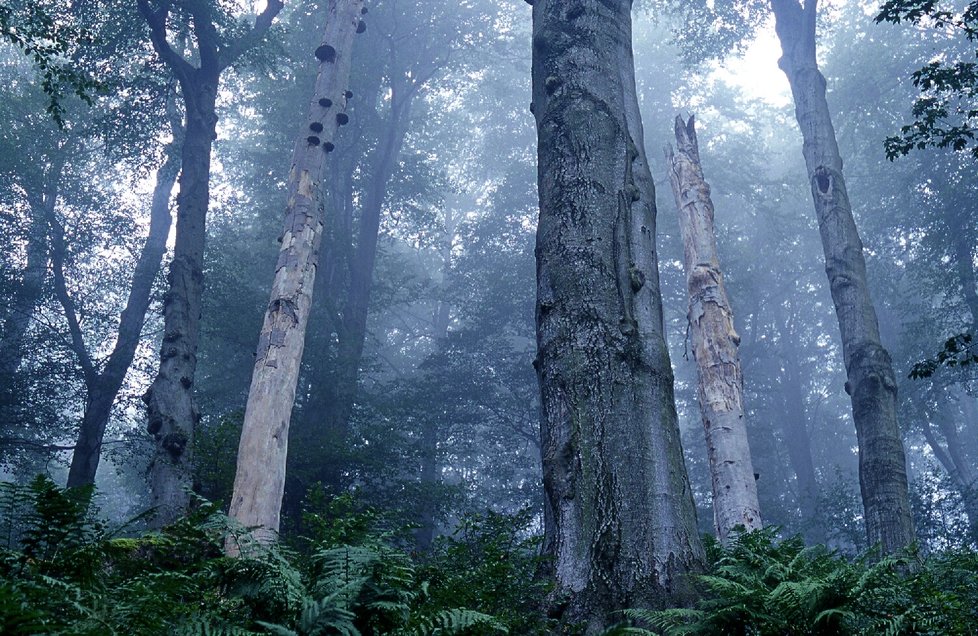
[60,128,183,487]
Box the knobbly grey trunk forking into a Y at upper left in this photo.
[137,0,283,526]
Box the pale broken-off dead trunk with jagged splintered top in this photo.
[666,117,761,543]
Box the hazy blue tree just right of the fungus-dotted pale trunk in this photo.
[297,2,501,489]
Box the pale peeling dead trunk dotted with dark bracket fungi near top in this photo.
[230,0,363,549]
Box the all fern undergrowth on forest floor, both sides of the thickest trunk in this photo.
[0,477,978,636]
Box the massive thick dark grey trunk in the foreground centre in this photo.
[533,0,703,633]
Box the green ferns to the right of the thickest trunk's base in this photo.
[618,529,978,636]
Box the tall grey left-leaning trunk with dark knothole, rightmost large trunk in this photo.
[771,0,914,553]
